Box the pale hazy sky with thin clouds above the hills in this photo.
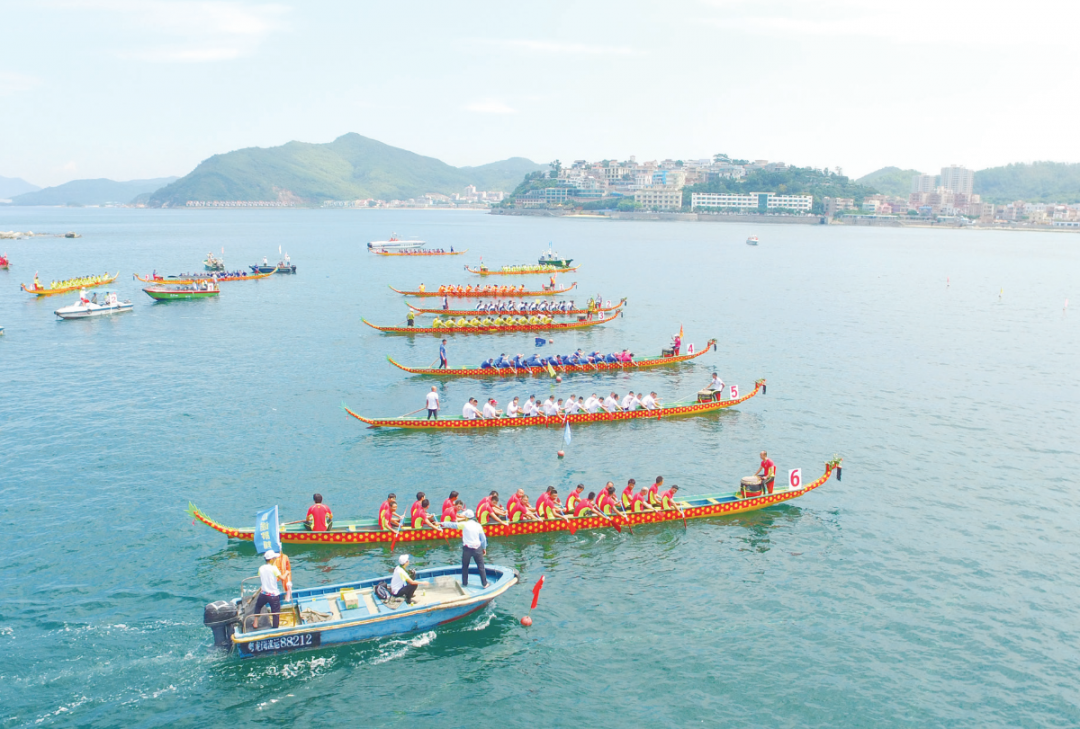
[0,0,1080,186]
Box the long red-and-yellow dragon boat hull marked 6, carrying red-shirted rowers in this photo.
[188,457,843,548]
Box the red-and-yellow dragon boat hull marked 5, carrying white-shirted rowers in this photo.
[341,379,766,431]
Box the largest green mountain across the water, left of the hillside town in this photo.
[150,134,541,206]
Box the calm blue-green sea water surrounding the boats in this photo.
[0,208,1080,727]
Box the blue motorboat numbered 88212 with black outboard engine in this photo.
[203,565,517,658]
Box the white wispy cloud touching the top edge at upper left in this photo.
[59,0,289,64]
